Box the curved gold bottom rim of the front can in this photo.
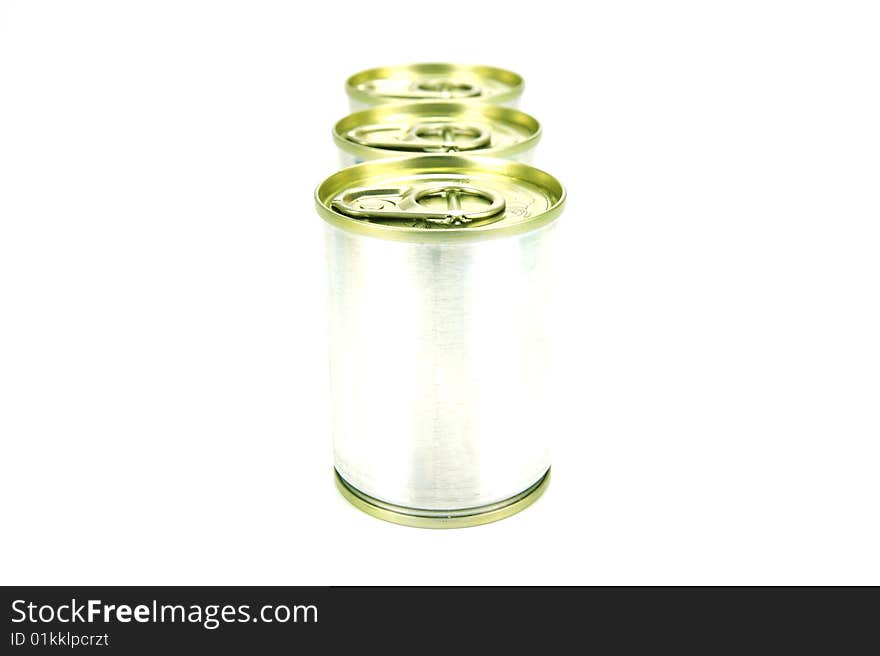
[333,469,550,528]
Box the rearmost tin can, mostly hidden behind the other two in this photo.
[345,64,523,112]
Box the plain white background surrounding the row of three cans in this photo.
[0,0,880,584]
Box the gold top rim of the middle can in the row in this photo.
[333,100,542,160]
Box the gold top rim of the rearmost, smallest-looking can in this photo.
[345,62,525,105]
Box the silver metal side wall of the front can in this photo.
[325,222,556,510]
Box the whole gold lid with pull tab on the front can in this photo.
[315,155,565,241]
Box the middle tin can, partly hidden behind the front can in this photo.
[333,102,541,168]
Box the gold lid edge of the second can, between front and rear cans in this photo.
[332,100,543,161]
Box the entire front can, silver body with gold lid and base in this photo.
[315,155,565,528]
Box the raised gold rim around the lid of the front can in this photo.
[315,154,567,243]
